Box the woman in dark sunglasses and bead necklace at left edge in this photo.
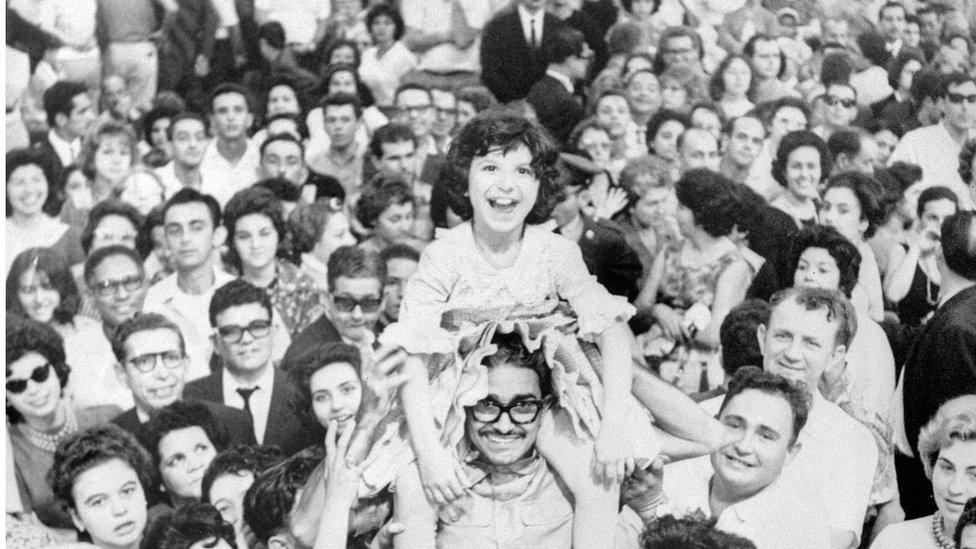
[6,316,121,533]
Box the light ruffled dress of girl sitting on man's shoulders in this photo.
[361,222,660,494]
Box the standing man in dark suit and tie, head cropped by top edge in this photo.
[481,0,563,103]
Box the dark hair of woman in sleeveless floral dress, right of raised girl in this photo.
[674,168,737,237]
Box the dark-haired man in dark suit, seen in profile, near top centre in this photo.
[525,27,593,143]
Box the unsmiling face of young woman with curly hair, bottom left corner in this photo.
[71,459,147,547]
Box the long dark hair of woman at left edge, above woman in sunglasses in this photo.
[7,248,81,324]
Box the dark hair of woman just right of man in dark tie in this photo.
[281,341,362,420]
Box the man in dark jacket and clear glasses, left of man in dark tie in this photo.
[112,313,255,452]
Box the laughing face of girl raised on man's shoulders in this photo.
[468,144,539,238]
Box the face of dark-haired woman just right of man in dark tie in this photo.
[308,362,363,433]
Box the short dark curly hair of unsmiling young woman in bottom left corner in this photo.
[47,423,156,509]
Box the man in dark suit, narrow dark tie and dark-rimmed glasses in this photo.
[185,279,319,455]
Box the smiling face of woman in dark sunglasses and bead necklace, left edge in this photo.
[7,351,61,420]
